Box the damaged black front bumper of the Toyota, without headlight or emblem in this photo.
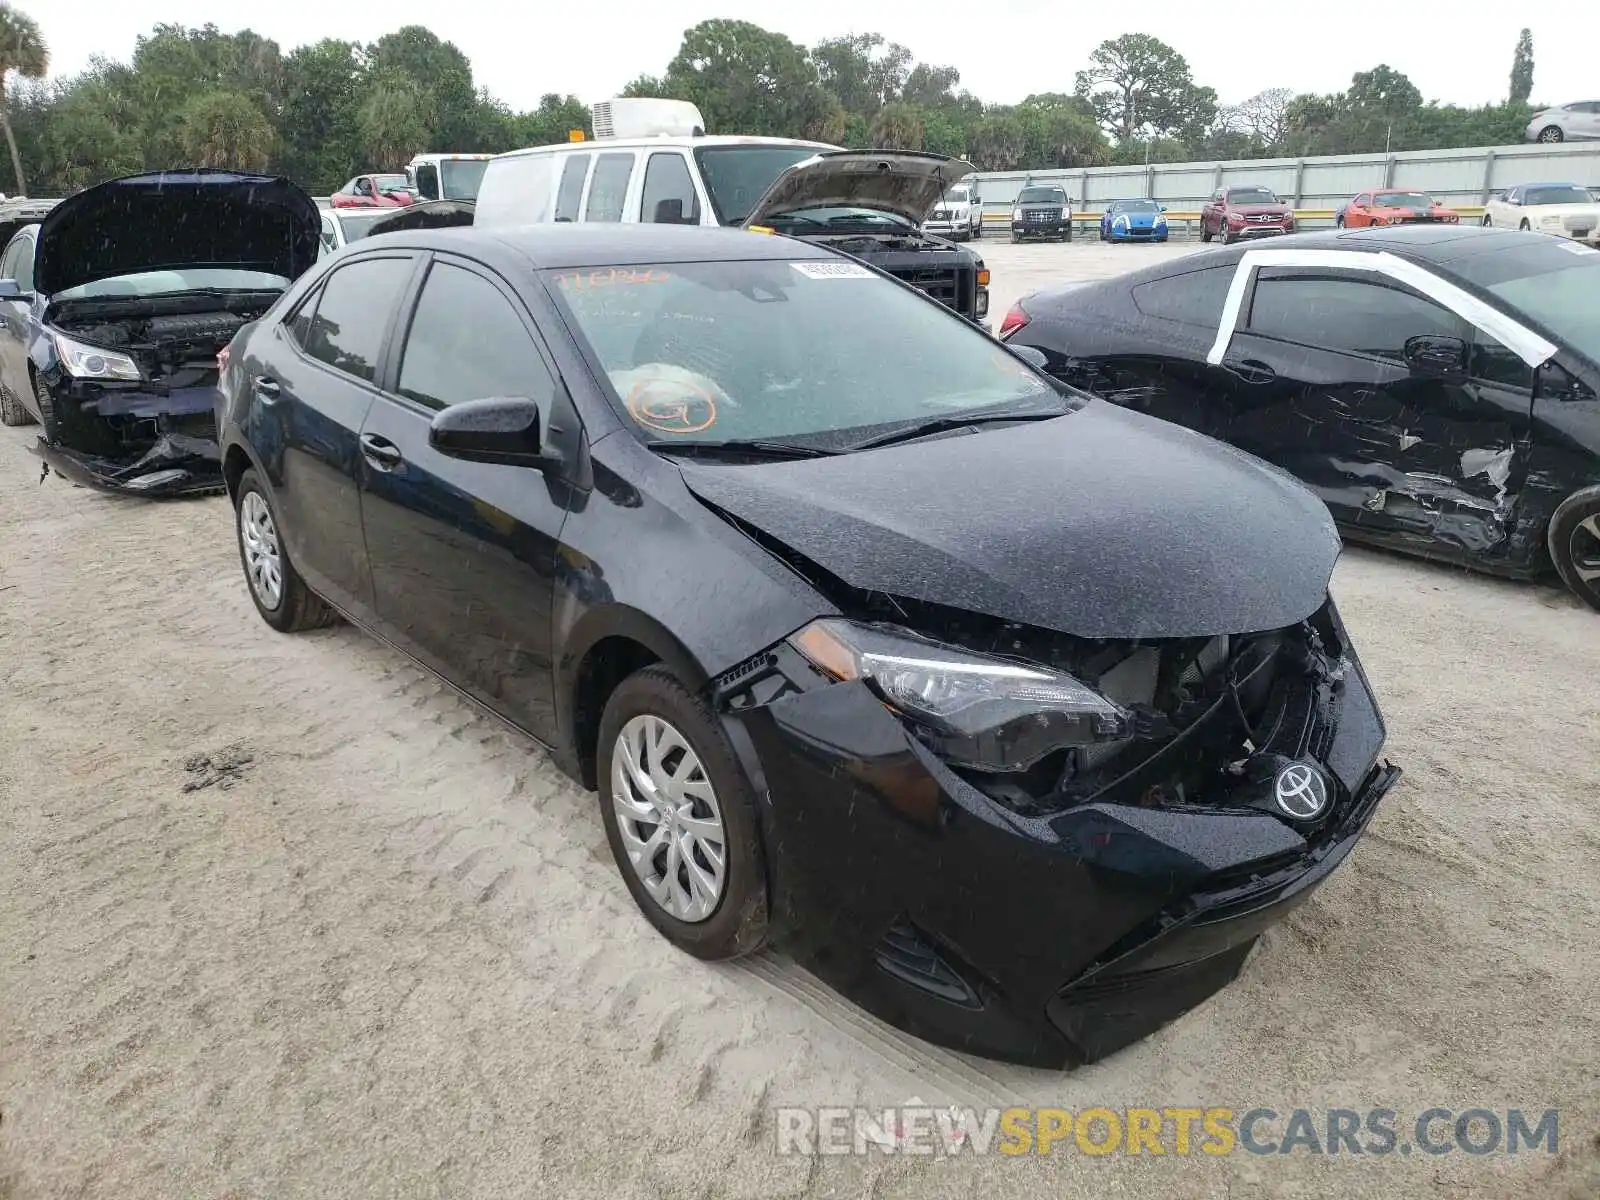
[714,610,1400,1067]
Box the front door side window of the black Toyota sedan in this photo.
[400,262,555,411]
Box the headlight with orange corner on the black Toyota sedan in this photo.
[789,618,1133,771]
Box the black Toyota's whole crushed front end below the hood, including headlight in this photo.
[714,597,1398,1067]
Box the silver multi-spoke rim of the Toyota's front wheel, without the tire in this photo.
[611,714,728,925]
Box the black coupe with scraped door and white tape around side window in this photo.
[1002,226,1600,608]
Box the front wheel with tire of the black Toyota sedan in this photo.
[597,667,768,958]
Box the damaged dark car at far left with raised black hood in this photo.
[0,170,320,496]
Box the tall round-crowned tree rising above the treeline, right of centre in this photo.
[1077,34,1216,141]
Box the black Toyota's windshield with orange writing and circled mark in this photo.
[546,259,1064,446]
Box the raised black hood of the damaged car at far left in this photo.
[34,166,322,296]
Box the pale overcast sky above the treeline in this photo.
[31,0,1580,116]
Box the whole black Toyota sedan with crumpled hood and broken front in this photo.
[219,226,1397,1064]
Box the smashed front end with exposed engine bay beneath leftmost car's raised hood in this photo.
[38,291,280,494]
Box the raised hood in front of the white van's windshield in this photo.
[744,150,978,226]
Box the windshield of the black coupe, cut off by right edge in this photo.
[1451,248,1600,363]
